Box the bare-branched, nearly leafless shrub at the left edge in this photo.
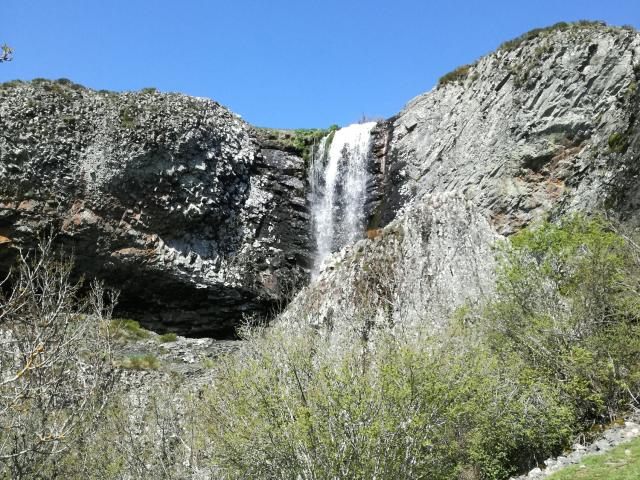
[0,240,115,478]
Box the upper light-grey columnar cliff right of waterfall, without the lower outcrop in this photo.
[371,23,640,234]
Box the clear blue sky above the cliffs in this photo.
[0,0,640,128]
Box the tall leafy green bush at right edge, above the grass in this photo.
[482,217,640,425]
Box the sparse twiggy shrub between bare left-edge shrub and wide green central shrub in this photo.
[54,377,208,480]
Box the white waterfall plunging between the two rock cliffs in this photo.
[309,122,375,276]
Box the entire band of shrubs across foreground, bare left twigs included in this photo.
[0,217,640,480]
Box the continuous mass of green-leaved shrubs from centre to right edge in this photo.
[201,217,640,480]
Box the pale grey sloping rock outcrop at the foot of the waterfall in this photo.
[279,192,500,347]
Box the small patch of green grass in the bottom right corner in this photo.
[547,438,640,480]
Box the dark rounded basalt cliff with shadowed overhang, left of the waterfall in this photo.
[0,81,312,335]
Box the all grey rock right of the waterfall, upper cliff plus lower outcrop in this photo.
[284,23,640,337]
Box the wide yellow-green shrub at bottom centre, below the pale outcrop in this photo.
[201,320,573,479]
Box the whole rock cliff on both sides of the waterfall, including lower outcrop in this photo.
[0,22,640,335]
